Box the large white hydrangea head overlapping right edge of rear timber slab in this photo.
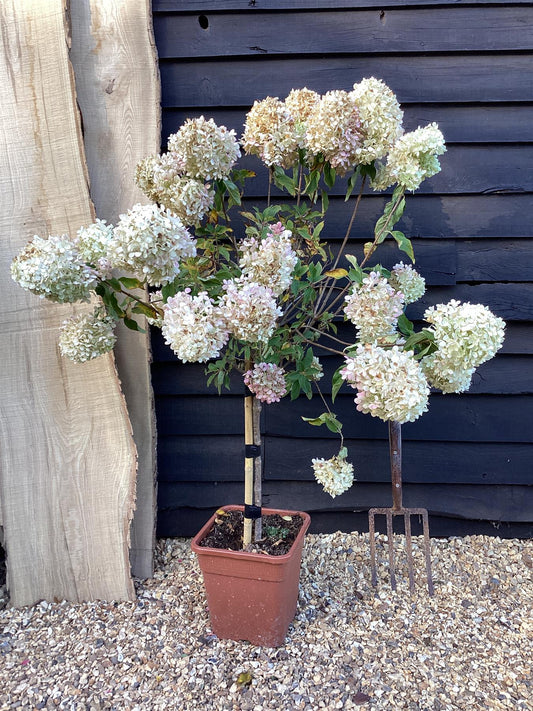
[109,204,196,286]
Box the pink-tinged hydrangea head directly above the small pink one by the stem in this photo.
[220,278,282,343]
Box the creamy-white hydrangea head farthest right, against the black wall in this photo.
[422,299,505,393]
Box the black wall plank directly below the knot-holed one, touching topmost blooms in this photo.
[160,54,533,107]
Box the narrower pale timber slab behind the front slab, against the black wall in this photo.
[70,0,161,578]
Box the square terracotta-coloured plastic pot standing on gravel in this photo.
[191,506,311,647]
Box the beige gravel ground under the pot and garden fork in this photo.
[0,533,533,711]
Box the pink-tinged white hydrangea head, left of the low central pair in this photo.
[161,289,229,363]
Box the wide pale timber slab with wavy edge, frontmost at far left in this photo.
[0,0,135,606]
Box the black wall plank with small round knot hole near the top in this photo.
[154,7,533,59]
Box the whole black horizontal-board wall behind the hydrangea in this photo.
[149,0,533,536]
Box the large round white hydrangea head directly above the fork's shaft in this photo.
[341,344,429,423]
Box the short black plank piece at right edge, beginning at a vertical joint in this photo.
[456,240,533,282]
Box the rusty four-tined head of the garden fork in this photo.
[368,506,434,597]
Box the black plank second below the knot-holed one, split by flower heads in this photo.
[162,104,533,144]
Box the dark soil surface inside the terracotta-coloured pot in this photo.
[200,510,303,555]
